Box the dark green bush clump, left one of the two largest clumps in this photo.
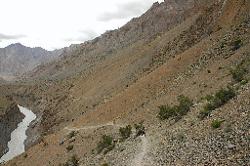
[158,95,193,120]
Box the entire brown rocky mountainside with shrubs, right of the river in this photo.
[0,0,250,166]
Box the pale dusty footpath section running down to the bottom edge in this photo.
[131,135,150,166]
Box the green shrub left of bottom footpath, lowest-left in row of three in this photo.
[97,135,115,154]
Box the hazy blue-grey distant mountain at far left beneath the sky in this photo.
[0,43,61,77]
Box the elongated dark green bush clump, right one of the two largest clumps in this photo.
[199,87,236,119]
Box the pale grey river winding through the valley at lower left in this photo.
[0,105,36,163]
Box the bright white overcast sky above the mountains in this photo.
[0,0,163,50]
